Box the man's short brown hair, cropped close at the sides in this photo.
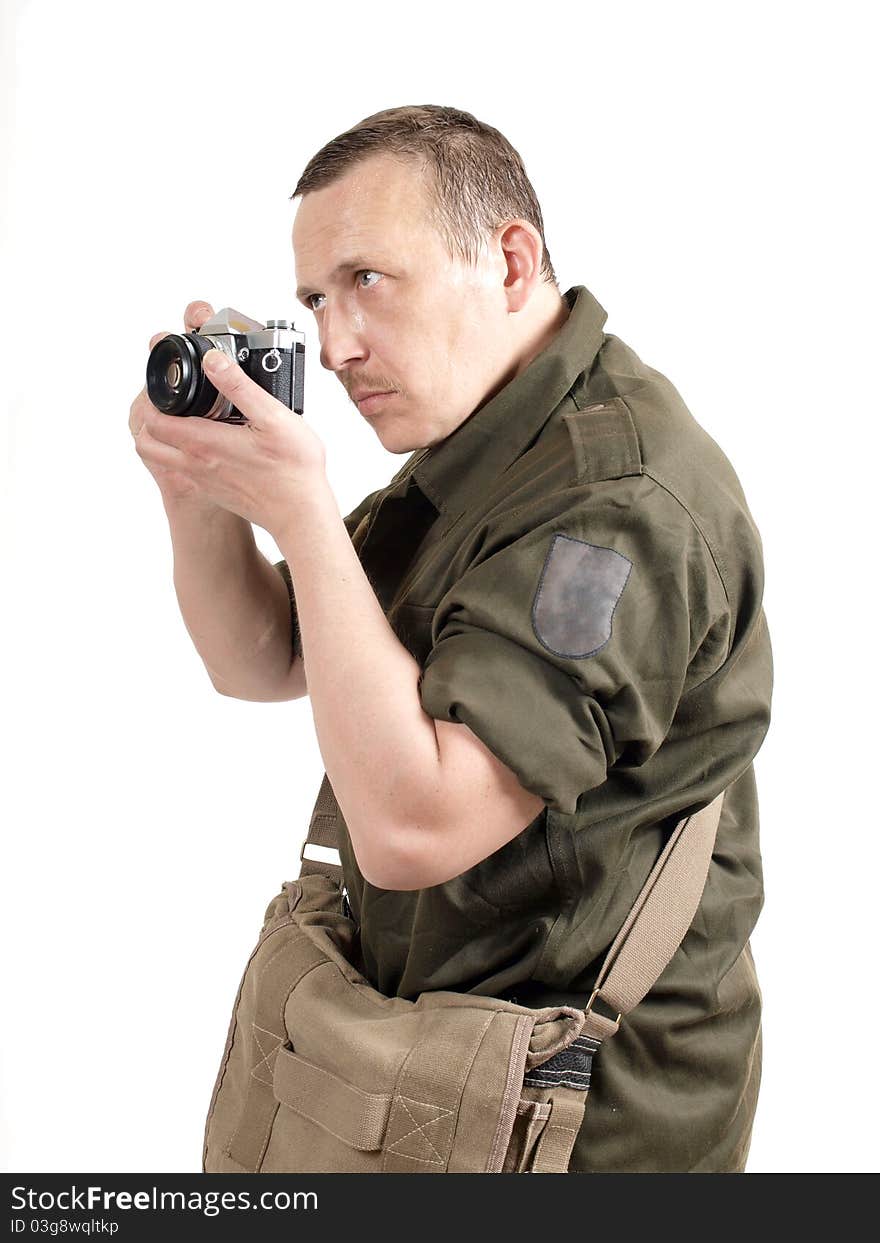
[291,103,558,285]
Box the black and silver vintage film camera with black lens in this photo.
[147,307,306,424]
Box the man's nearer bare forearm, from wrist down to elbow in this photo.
[276,480,441,889]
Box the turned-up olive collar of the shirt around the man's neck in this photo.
[398,285,608,521]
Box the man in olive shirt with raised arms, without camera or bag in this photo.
[131,106,772,1172]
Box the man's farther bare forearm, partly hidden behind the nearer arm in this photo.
[165,501,306,702]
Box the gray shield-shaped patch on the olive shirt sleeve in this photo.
[532,534,633,660]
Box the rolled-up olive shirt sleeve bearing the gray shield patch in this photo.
[419,479,725,814]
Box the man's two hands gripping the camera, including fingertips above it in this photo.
[129,303,326,539]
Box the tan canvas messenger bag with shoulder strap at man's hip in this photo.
[203,787,723,1173]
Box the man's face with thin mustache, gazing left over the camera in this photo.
[293,155,513,454]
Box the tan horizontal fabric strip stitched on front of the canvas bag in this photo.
[272,1045,392,1152]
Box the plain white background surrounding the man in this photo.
[0,0,879,1172]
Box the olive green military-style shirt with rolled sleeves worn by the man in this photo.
[278,286,773,1172]
